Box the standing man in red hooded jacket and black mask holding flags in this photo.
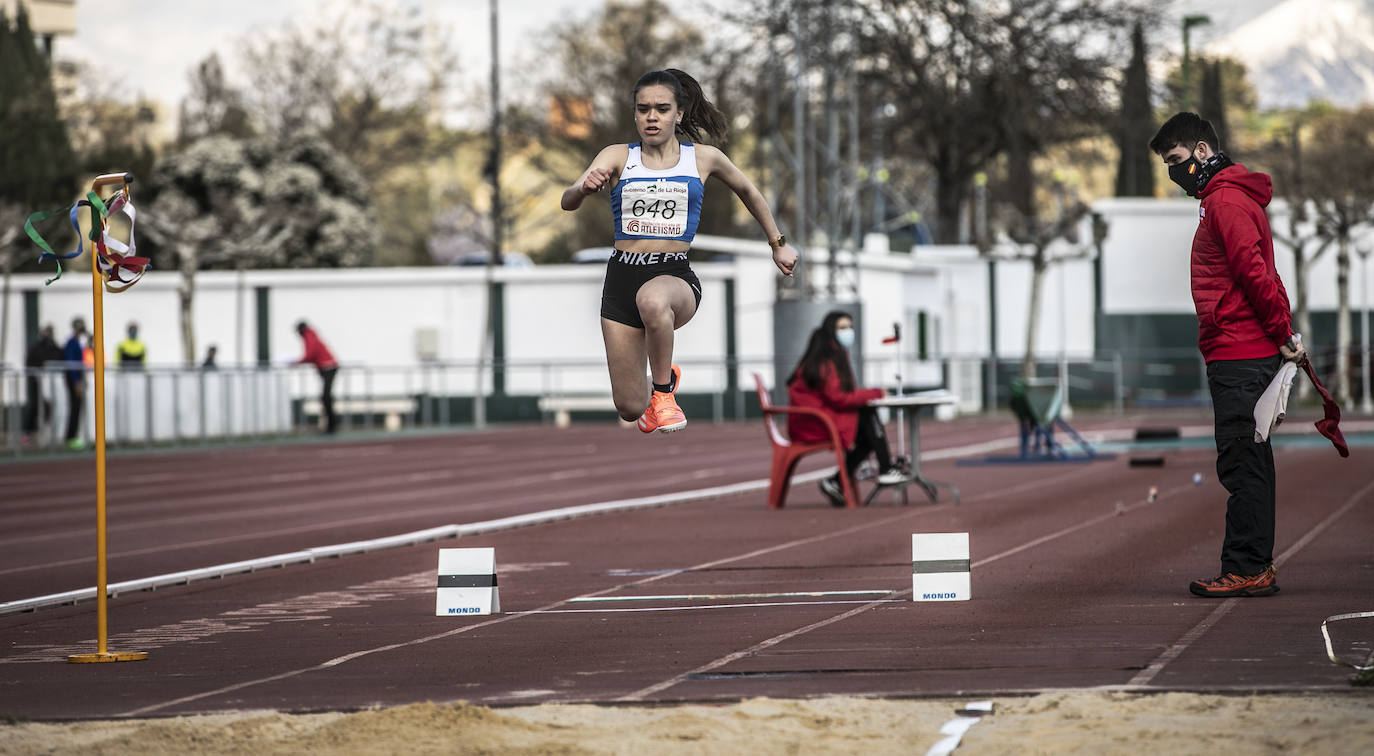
[1150,113,1305,598]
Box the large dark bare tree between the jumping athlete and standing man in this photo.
[866,0,1139,242]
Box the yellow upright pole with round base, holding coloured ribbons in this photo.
[67,173,148,664]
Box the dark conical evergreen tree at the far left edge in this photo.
[0,4,76,210]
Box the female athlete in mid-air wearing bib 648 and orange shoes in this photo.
[562,69,797,433]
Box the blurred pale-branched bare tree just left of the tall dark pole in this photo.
[242,0,463,264]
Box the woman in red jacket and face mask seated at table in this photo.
[787,311,905,507]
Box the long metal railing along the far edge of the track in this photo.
[0,349,1363,456]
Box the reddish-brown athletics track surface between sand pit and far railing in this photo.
[0,418,1374,719]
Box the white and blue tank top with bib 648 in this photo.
[610,142,703,243]
